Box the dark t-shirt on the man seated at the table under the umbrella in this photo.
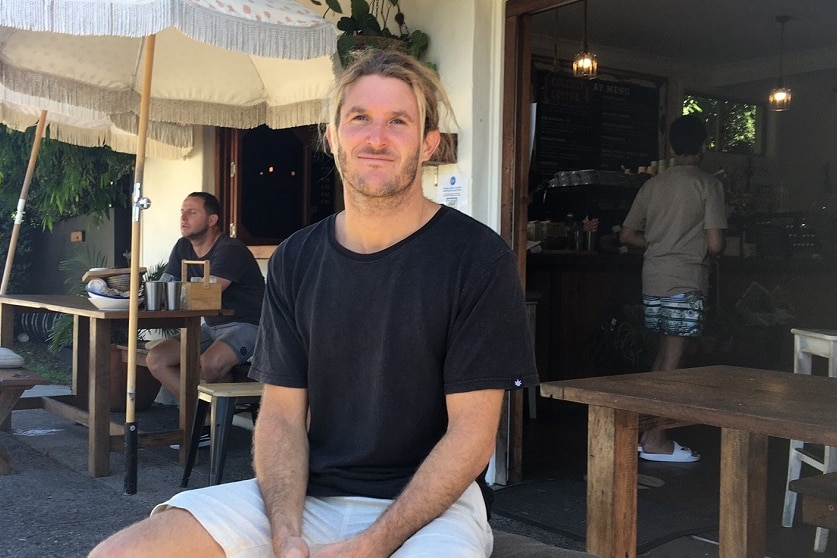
[165,234,264,326]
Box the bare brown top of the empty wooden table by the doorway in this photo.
[541,366,837,446]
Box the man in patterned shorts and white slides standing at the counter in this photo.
[620,115,727,462]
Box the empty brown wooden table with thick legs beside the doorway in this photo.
[541,366,837,558]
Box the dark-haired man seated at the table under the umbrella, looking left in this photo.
[146,192,264,400]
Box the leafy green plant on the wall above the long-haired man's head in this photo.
[311,0,436,70]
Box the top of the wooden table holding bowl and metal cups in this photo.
[0,295,233,320]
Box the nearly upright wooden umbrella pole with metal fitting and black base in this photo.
[124,35,156,494]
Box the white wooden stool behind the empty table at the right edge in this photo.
[782,329,837,552]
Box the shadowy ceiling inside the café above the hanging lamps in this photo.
[534,0,837,85]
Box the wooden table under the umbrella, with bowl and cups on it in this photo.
[0,295,232,477]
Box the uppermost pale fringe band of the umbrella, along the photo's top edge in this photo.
[0,0,337,60]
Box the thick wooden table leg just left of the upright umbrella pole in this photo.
[87,318,111,477]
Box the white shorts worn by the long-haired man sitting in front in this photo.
[151,479,494,558]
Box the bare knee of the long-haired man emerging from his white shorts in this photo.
[89,508,225,558]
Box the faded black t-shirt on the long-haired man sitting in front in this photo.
[250,207,538,504]
